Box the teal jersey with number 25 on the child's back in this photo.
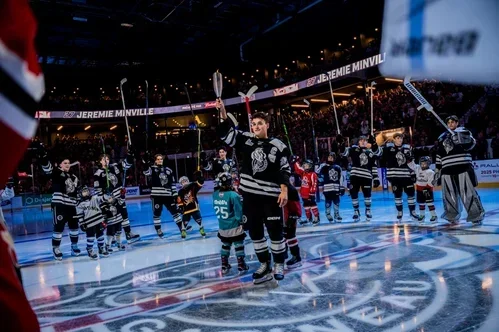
[213,190,246,242]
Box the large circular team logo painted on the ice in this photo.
[32,226,499,332]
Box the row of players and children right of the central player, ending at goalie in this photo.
[291,115,485,226]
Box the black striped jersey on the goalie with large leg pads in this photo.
[435,127,476,175]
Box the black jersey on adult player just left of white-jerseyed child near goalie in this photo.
[374,142,414,182]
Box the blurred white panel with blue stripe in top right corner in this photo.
[380,0,499,84]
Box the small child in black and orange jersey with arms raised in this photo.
[177,171,206,239]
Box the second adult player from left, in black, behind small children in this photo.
[94,153,140,249]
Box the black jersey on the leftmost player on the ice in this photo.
[42,161,80,206]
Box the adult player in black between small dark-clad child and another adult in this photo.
[342,136,380,222]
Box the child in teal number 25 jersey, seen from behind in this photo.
[213,172,249,275]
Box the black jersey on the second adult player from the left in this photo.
[94,156,133,199]
